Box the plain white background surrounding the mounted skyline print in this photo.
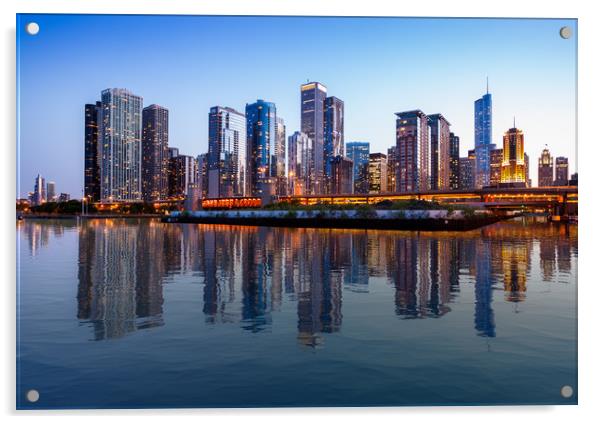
[0,0,602,424]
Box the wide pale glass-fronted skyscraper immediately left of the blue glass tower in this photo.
[207,106,247,198]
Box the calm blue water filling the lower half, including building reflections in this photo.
[17,219,577,408]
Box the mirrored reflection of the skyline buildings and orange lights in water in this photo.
[20,220,577,346]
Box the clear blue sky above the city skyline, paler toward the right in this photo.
[17,15,577,197]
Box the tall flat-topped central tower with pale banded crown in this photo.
[301,82,326,194]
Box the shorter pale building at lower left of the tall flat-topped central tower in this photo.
[288,131,313,196]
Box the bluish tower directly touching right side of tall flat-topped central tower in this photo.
[324,96,345,191]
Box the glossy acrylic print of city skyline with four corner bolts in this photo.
[16,14,578,409]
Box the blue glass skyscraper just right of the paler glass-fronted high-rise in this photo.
[245,99,276,196]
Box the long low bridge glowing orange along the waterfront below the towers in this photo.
[202,186,578,216]
